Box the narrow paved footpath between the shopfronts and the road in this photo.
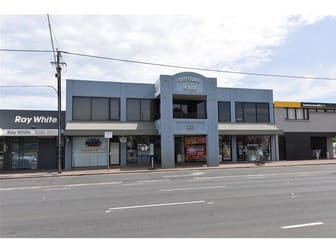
[0,159,336,179]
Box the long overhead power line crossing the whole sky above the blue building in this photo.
[0,49,336,81]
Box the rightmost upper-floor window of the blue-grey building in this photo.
[235,102,270,122]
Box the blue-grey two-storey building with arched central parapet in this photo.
[65,72,281,169]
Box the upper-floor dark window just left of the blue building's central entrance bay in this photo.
[127,98,153,121]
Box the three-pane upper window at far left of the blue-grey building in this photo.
[72,97,120,121]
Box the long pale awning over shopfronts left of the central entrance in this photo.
[65,122,158,136]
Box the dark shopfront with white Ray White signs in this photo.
[0,110,64,170]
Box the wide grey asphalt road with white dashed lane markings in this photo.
[0,165,336,238]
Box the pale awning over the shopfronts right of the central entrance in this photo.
[218,123,283,135]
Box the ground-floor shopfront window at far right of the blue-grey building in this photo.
[237,136,271,161]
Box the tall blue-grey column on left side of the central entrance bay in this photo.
[160,80,175,168]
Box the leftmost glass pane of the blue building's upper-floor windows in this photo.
[72,97,91,121]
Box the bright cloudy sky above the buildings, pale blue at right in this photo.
[0,0,336,110]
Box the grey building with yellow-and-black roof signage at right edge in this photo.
[274,101,336,160]
